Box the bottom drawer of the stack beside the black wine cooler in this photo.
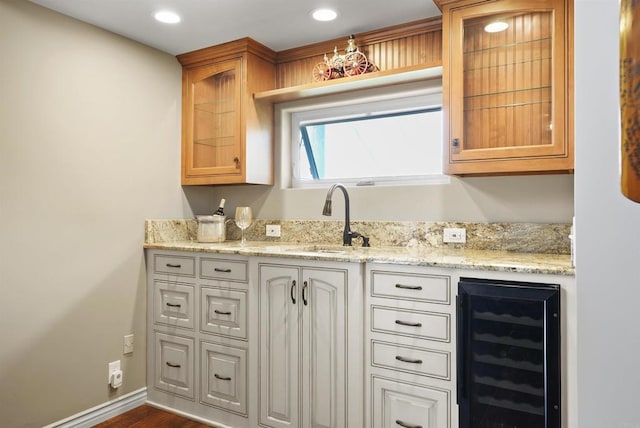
[371,376,449,428]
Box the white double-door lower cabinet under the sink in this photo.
[255,259,364,428]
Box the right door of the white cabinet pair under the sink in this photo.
[301,269,347,428]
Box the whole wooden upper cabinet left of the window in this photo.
[177,38,275,185]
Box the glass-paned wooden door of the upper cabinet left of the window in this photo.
[183,59,242,178]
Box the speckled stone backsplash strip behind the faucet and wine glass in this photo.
[145,219,571,254]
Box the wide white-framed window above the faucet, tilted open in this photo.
[291,92,443,187]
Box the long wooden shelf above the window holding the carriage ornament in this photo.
[253,66,442,103]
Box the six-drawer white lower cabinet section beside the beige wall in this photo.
[146,250,257,428]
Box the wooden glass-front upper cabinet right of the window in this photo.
[441,0,573,175]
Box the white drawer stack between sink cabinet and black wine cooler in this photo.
[364,263,457,428]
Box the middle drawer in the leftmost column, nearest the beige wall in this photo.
[153,281,194,329]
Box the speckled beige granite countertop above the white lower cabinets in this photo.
[144,241,575,275]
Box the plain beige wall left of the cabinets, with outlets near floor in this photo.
[0,0,191,428]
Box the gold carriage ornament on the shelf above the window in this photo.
[313,36,378,82]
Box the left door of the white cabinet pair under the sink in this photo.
[259,266,302,428]
